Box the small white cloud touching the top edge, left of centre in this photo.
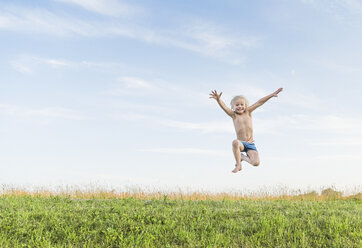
[55,0,141,17]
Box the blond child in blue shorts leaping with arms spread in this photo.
[210,88,283,173]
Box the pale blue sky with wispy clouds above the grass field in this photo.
[0,0,362,192]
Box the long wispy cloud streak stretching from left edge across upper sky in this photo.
[0,5,261,65]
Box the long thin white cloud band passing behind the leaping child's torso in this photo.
[143,115,362,142]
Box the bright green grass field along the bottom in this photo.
[0,195,362,248]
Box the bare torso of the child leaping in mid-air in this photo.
[232,111,253,142]
